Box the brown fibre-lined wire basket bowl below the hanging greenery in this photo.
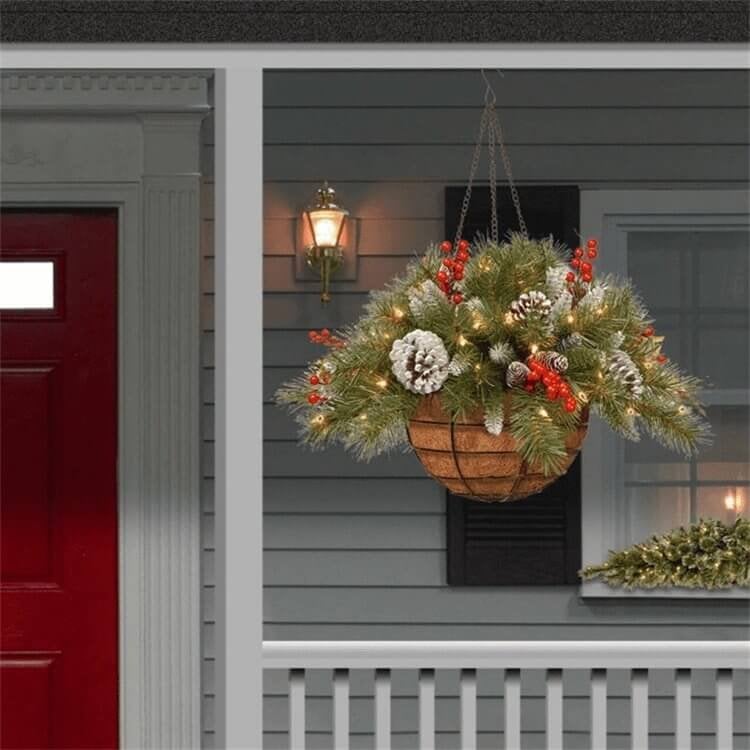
[408,395,588,503]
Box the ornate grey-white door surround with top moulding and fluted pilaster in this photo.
[1,72,209,750]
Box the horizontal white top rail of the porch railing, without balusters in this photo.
[263,641,750,669]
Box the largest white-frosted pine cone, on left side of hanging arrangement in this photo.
[390,329,449,395]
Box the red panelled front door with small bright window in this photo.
[0,211,118,750]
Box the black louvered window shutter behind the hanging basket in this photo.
[445,185,581,586]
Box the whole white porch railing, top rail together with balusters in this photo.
[263,641,750,750]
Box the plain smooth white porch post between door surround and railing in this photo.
[214,67,263,750]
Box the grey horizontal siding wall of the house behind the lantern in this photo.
[202,70,750,747]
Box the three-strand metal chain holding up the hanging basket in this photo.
[453,70,529,247]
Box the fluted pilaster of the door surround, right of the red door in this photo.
[141,112,202,750]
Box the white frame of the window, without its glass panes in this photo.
[580,189,750,599]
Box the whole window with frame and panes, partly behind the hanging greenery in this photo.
[581,190,750,597]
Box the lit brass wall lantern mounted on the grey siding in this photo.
[301,182,349,303]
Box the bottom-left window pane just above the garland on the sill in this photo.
[625,487,690,544]
